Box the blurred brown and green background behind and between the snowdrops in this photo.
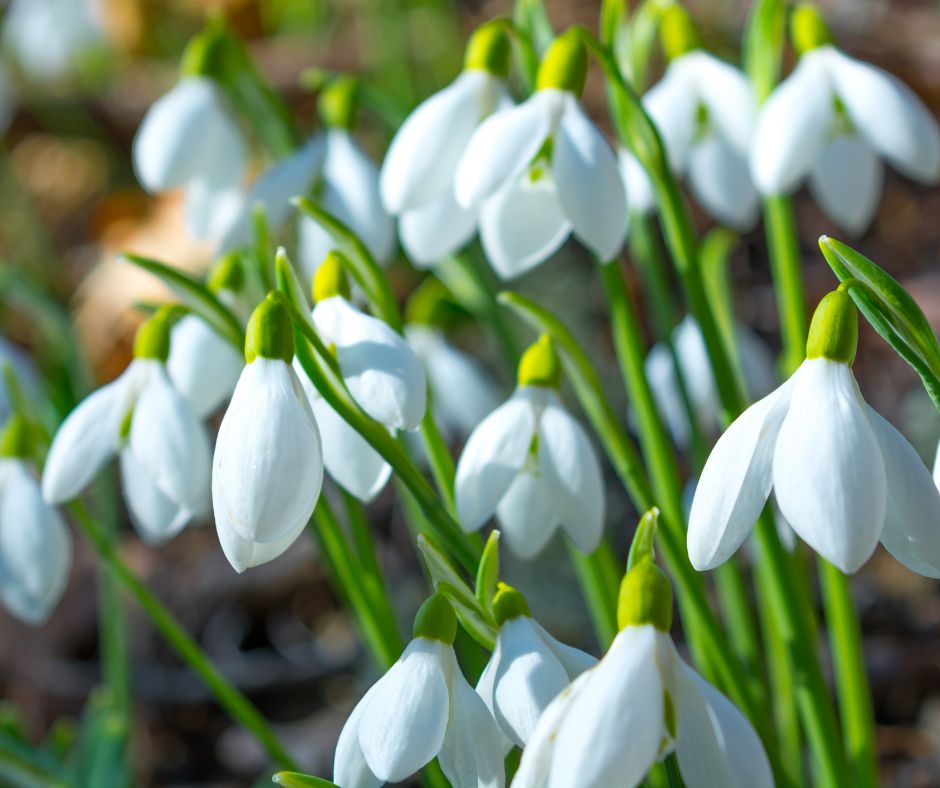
[0,0,940,786]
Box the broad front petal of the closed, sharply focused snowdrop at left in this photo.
[212,358,323,543]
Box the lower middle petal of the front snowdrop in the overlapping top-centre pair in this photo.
[480,172,571,280]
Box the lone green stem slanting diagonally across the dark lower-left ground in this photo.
[69,501,297,770]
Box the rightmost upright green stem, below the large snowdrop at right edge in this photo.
[817,558,878,788]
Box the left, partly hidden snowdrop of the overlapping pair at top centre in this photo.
[379,22,512,266]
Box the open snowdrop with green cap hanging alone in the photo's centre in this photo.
[455,336,604,558]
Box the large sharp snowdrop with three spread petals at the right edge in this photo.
[688,288,940,577]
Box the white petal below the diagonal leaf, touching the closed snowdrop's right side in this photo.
[310,397,392,502]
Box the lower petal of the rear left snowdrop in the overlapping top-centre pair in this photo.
[398,192,478,268]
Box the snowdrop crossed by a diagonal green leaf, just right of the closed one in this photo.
[294,252,427,501]
